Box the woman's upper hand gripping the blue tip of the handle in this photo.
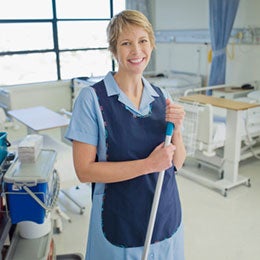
[165,99,185,130]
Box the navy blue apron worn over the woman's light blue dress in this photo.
[93,81,181,248]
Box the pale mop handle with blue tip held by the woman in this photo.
[142,122,174,260]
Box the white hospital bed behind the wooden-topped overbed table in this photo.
[183,86,260,160]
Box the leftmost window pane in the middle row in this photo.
[0,23,53,52]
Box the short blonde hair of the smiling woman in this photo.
[107,10,155,55]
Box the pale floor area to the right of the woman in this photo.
[178,156,260,260]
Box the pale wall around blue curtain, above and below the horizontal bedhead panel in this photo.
[153,0,260,85]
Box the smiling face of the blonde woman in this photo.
[115,25,153,74]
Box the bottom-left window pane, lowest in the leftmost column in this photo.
[0,53,57,85]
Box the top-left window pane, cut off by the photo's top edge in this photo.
[0,0,53,19]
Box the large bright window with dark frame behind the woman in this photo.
[0,0,125,85]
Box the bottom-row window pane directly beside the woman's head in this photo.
[60,50,111,79]
